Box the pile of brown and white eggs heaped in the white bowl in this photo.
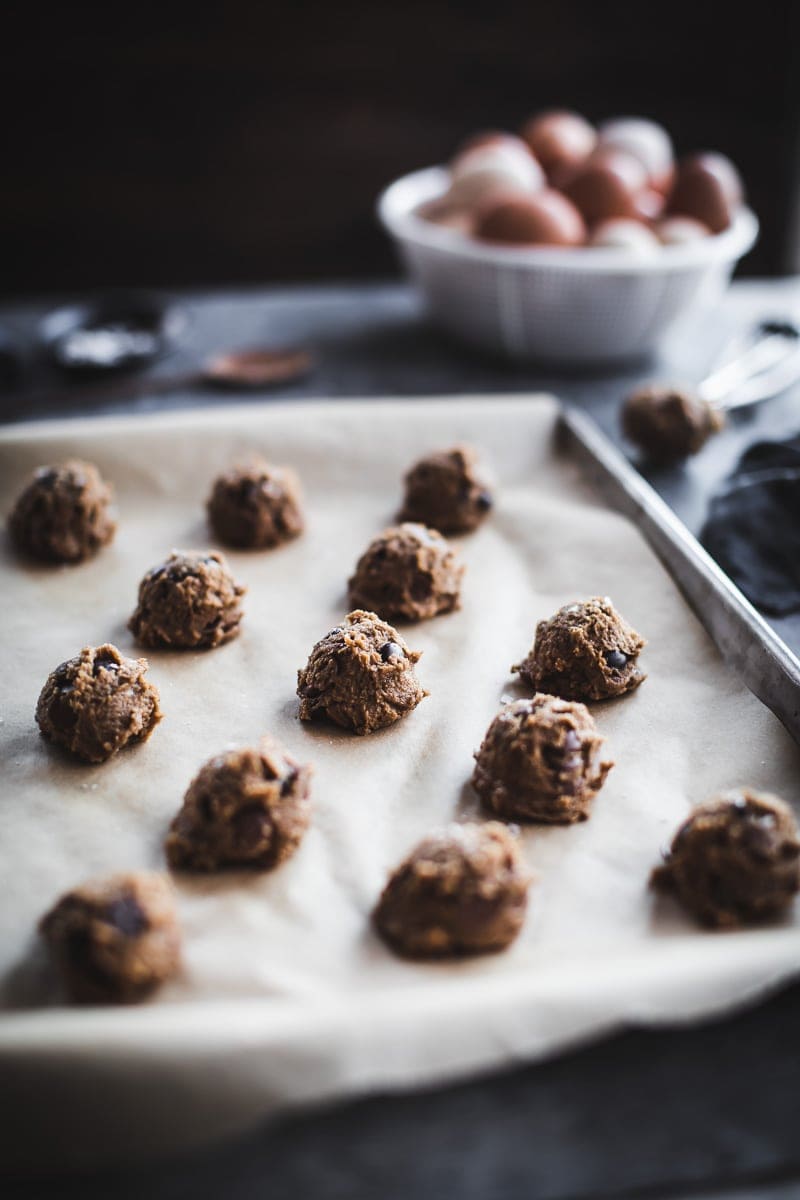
[419,112,744,254]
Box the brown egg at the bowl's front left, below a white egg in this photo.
[475,188,587,246]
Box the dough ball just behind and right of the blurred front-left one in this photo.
[164,738,311,871]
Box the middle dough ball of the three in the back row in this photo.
[206,460,305,550]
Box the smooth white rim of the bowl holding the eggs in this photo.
[377,167,758,275]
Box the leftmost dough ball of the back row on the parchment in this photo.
[8,458,116,563]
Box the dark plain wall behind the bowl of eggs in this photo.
[0,0,800,295]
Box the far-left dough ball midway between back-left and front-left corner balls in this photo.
[36,644,162,762]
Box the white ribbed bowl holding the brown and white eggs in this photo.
[378,167,758,362]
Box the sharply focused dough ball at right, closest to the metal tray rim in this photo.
[511,596,646,701]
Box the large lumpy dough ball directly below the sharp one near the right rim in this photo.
[473,694,613,824]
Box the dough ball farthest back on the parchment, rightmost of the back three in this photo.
[398,446,494,534]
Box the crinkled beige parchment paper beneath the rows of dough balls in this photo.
[0,397,800,1165]
